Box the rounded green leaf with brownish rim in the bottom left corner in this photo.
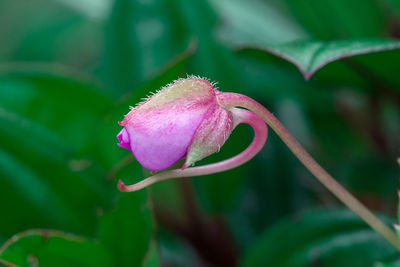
[0,229,115,267]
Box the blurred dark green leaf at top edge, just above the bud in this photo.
[101,0,191,93]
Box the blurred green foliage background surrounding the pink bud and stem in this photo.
[0,0,400,267]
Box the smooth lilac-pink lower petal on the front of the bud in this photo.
[125,103,210,171]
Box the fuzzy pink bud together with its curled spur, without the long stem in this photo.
[117,77,268,191]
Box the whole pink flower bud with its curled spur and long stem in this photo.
[117,77,399,253]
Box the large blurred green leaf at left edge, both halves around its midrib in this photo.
[0,65,115,236]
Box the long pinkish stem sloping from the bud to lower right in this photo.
[218,93,400,250]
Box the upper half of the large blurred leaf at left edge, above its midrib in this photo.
[0,63,111,157]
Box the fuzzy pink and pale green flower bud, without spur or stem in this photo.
[117,78,233,171]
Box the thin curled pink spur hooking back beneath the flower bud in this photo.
[118,108,268,192]
